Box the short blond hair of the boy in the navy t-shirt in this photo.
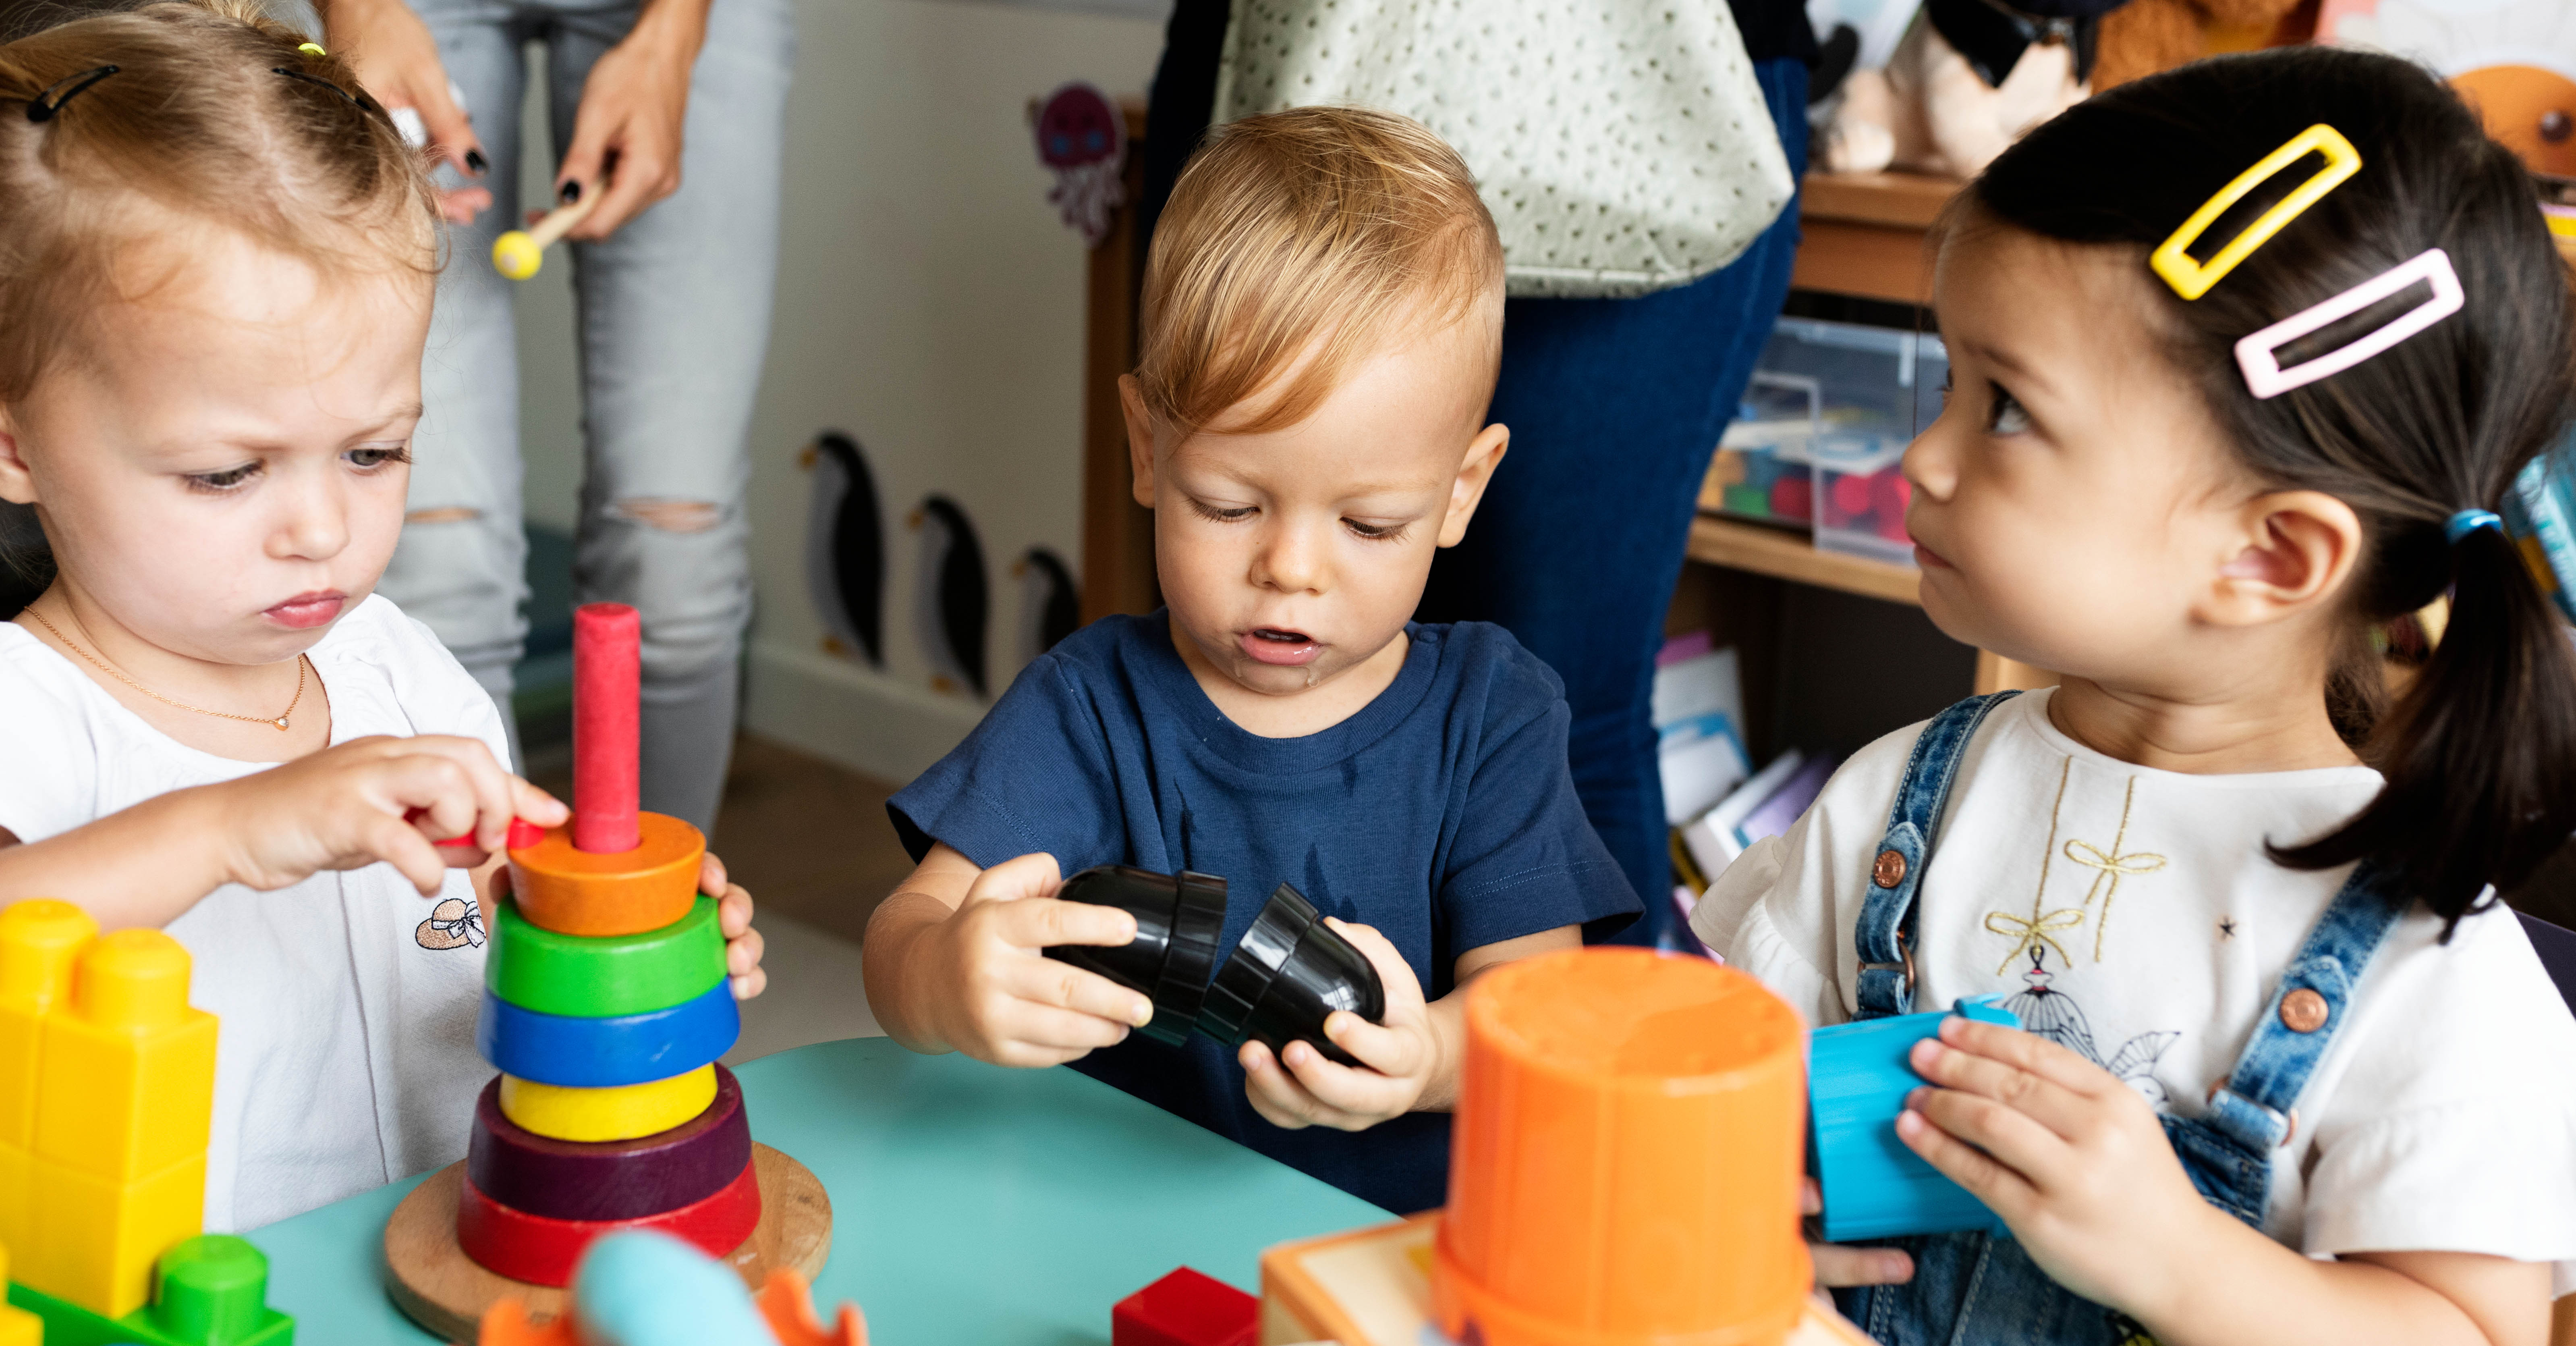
[1136,108,1502,436]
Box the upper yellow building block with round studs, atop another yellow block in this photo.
[33,931,214,1181]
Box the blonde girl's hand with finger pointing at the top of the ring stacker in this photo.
[203,735,572,897]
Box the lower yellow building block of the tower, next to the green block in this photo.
[15,1150,206,1318]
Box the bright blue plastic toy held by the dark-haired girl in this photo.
[1806,995,2022,1243]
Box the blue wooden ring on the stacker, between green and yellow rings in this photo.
[474,980,742,1088]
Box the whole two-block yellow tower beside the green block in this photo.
[18,931,216,1318]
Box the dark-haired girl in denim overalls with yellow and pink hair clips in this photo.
[1692,49,2576,1346]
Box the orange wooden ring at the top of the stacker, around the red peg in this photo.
[510,812,706,936]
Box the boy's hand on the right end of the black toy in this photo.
[1236,915,1445,1132]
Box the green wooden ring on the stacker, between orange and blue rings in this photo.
[484,897,724,1018]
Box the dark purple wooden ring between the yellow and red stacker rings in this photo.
[466,1065,752,1219]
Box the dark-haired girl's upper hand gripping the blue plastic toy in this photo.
[1896,1016,2228,1310]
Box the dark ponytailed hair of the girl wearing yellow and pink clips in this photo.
[1970,46,2576,939]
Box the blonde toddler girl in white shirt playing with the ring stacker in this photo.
[0,0,763,1230]
